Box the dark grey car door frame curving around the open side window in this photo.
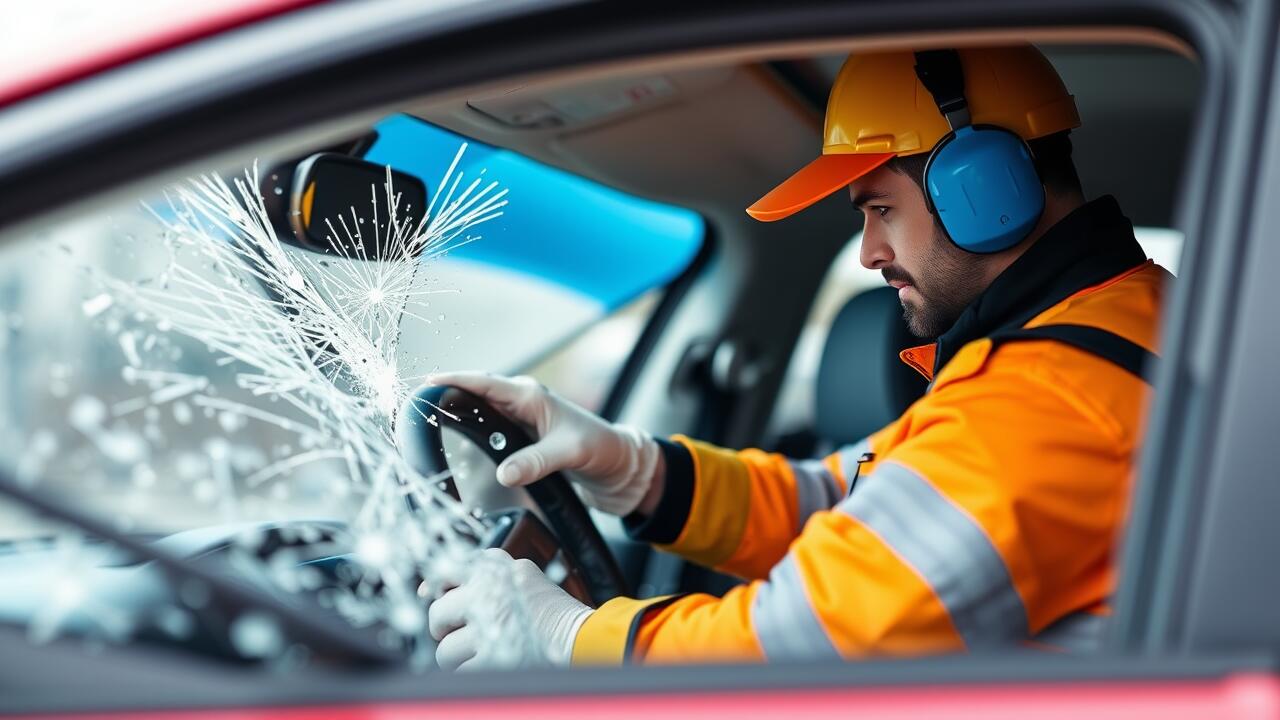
[0,0,1280,703]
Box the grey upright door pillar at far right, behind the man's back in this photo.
[1115,3,1280,653]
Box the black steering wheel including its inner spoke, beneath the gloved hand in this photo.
[396,386,627,606]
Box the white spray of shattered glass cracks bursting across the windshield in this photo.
[19,143,545,667]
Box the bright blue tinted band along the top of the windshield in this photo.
[365,115,704,310]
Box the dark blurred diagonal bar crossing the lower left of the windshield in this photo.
[0,470,406,665]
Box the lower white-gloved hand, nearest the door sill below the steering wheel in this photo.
[428,547,594,670]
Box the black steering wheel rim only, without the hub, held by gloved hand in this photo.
[397,386,628,606]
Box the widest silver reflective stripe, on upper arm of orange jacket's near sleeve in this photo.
[838,462,1028,648]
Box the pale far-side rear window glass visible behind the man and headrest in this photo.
[767,227,1183,441]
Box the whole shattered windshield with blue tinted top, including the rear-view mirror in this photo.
[0,115,704,669]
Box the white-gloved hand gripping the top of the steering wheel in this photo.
[428,373,662,515]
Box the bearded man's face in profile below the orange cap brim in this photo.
[849,167,992,338]
